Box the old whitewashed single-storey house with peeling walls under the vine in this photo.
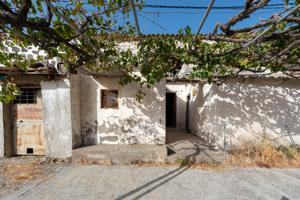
[0,41,300,158]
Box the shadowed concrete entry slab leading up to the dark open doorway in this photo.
[166,129,226,163]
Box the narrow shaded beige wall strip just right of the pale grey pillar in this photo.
[70,74,82,148]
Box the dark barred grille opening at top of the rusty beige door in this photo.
[14,88,39,104]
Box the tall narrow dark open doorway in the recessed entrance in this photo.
[166,93,176,128]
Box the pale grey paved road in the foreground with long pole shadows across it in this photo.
[3,165,300,200]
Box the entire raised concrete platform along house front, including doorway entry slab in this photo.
[72,129,226,165]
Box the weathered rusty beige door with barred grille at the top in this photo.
[13,88,45,155]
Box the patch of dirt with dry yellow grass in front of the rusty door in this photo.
[0,156,62,198]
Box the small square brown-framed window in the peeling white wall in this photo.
[101,90,118,108]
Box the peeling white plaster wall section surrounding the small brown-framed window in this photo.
[80,74,165,145]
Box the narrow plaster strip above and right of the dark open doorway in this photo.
[166,83,191,129]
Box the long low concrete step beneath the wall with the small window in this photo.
[72,144,167,165]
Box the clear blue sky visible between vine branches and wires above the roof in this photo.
[127,0,294,34]
